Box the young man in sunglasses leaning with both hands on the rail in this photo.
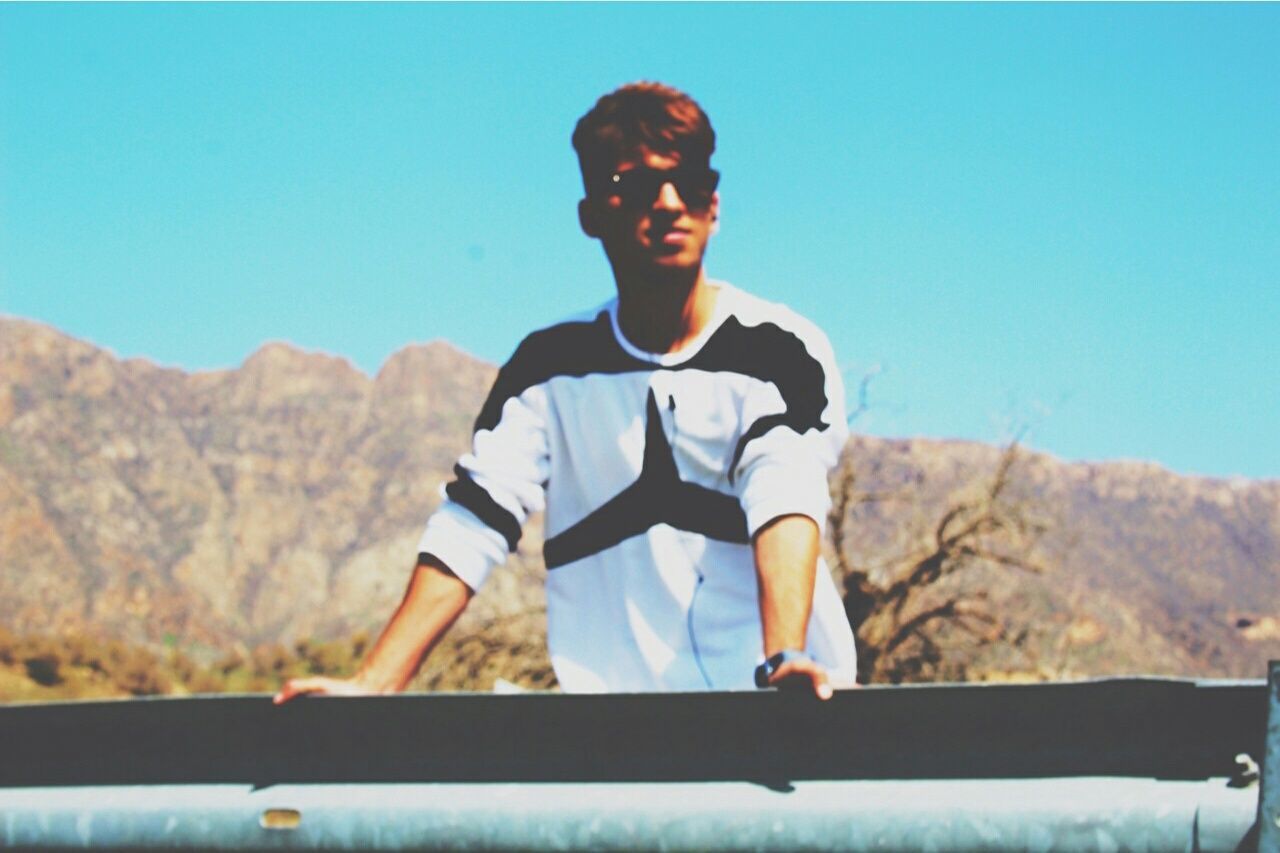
[276,83,856,702]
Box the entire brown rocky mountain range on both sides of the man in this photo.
[0,318,1280,676]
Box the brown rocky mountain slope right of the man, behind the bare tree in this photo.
[846,437,1280,678]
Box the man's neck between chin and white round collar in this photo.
[617,266,717,355]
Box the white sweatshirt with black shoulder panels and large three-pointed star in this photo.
[419,283,856,692]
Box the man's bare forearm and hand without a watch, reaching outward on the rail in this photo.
[273,555,474,704]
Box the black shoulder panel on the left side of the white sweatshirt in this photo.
[475,311,653,432]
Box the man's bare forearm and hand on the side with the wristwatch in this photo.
[753,515,831,699]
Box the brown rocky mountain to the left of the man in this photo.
[0,319,539,651]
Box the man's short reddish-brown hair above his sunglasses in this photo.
[573,82,716,187]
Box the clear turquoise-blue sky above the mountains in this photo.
[0,4,1280,478]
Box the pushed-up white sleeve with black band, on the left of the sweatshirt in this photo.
[419,351,549,589]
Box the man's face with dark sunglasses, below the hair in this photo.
[579,149,719,273]
